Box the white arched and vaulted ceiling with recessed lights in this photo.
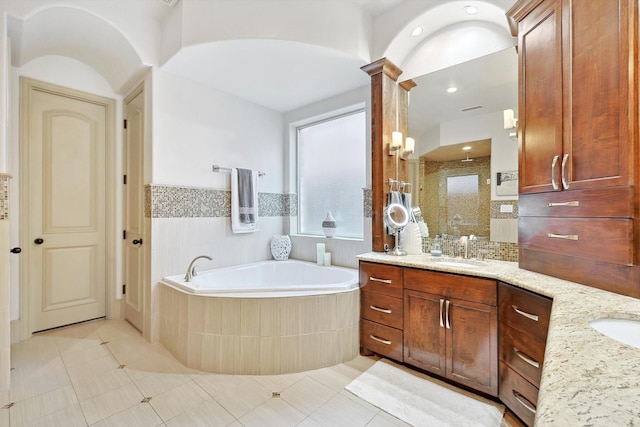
[3,0,513,112]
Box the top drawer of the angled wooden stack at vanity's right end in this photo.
[498,283,552,342]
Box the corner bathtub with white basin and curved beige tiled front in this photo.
[158,260,360,375]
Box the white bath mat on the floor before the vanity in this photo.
[345,360,504,427]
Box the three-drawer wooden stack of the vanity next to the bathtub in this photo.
[360,261,403,362]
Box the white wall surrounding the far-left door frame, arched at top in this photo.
[8,56,122,320]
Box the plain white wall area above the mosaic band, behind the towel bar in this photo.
[152,70,284,193]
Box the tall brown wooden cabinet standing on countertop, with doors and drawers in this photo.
[507,0,640,297]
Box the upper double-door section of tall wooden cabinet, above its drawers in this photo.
[507,0,638,194]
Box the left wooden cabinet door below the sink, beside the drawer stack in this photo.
[404,291,446,376]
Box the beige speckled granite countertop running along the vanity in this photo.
[358,252,640,427]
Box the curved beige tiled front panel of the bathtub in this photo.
[158,285,360,375]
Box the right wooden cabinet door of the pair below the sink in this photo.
[445,299,498,396]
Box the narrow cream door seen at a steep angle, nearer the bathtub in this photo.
[124,91,144,332]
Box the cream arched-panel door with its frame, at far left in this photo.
[21,79,110,332]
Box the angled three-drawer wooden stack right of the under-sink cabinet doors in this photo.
[498,283,552,426]
